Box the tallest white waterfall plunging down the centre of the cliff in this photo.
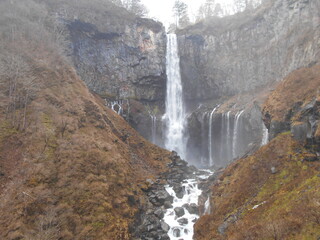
[165,34,186,158]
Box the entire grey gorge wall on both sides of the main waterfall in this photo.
[64,0,320,169]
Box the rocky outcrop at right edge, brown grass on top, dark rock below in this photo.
[263,65,320,149]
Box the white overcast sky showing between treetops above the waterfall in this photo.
[142,0,233,26]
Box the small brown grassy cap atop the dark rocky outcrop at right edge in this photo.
[263,65,320,122]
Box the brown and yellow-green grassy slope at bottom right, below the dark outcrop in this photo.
[195,134,320,240]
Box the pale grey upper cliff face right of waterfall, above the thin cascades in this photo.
[179,0,320,100]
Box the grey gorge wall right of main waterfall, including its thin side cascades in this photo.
[178,0,320,167]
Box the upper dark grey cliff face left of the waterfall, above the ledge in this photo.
[68,15,166,101]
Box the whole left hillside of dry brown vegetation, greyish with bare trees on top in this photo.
[0,0,169,240]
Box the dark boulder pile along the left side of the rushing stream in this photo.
[132,152,198,240]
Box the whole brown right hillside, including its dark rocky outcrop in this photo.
[196,66,320,240]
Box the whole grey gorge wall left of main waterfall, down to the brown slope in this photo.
[59,3,166,140]
